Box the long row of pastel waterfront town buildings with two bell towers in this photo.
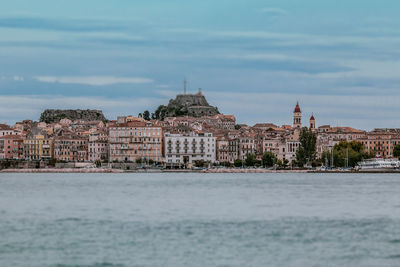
[0,104,400,168]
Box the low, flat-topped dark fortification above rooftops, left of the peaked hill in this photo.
[40,109,107,123]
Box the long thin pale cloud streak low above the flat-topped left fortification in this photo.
[35,76,153,86]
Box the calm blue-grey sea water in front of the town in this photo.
[0,173,400,267]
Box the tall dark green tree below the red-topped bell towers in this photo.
[296,127,317,167]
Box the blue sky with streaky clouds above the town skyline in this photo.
[0,0,400,130]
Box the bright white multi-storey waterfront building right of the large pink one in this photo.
[164,132,216,165]
